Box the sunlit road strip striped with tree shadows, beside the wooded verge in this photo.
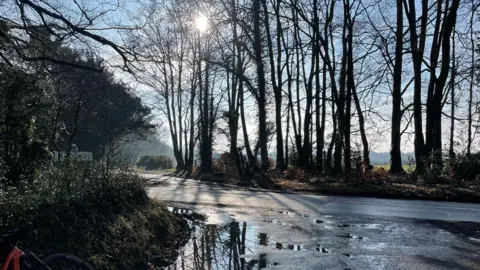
[144,175,480,222]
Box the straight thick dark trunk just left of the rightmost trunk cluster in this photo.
[389,0,404,174]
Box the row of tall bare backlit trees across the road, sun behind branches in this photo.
[138,0,479,180]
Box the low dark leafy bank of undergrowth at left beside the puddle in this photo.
[0,163,188,269]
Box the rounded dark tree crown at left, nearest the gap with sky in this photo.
[44,55,154,158]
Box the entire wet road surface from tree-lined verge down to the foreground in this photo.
[144,175,480,269]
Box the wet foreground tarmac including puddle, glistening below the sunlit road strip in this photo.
[166,203,480,270]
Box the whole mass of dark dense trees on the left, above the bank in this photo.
[0,39,154,183]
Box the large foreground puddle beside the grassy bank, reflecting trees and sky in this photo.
[165,207,314,270]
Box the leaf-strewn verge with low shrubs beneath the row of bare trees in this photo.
[192,160,480,203]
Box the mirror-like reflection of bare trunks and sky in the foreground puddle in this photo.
[167,221,294,270]
